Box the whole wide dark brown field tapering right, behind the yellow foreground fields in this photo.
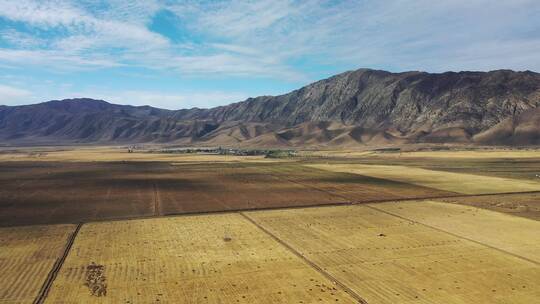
[0,159,454,226]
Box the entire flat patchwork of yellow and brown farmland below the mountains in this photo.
[0,147,540,304]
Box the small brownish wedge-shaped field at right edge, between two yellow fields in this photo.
[437,192,540,221]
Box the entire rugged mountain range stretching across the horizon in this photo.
[0,69,540,147]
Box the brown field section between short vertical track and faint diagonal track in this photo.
[156,163,348,214]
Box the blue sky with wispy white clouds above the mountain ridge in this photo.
[0,0,540,109]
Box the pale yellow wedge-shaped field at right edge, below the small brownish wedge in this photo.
[373,201,540,264]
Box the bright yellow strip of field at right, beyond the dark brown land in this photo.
[307,164,540,194]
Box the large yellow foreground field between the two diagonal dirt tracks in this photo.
[45,214,357,303]
